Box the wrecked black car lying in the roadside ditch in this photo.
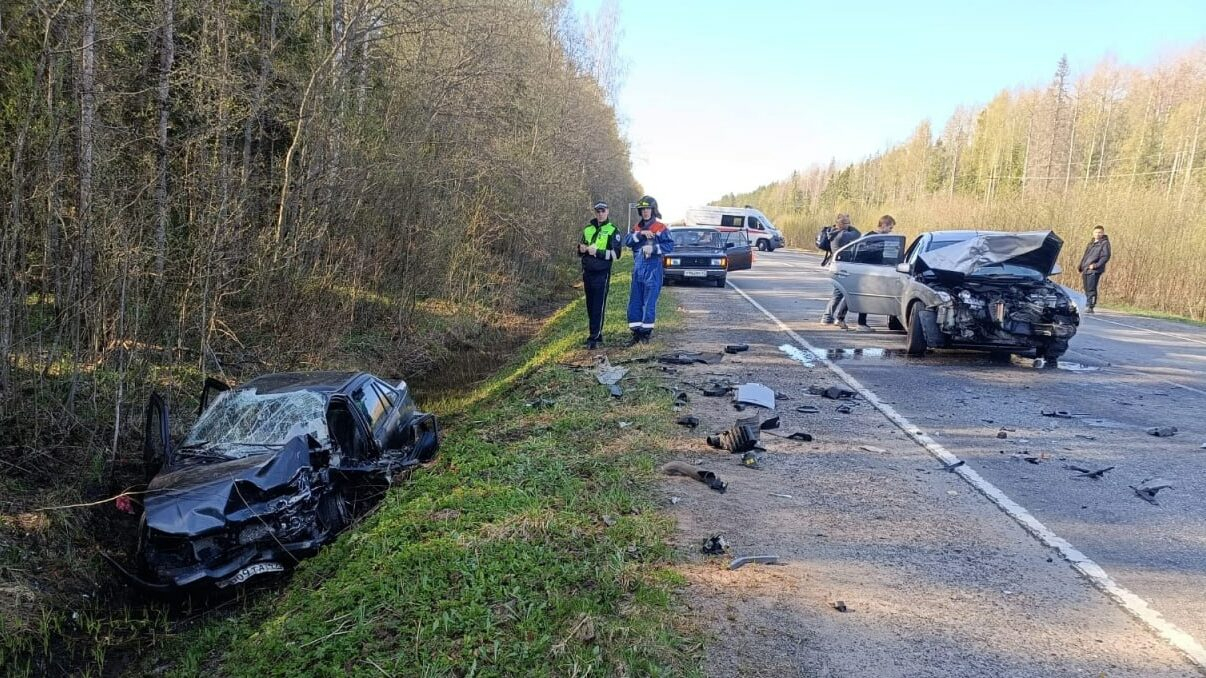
[130,372,439,592]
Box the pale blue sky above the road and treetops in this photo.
[573,0,1206,220]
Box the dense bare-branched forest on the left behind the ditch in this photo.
[0,0,636,405]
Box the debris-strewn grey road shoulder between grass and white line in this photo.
[661,287,1198,677]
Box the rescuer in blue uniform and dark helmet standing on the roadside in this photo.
[624,195,674,346]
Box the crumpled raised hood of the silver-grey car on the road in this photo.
[917,230,1064,277]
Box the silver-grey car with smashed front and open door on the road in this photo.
[829,230,1083,366]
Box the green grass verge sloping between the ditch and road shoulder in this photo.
[148,261,698,676]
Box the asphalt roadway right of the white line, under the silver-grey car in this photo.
[725,251,1206,664]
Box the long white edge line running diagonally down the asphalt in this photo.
[728,281,1206,672]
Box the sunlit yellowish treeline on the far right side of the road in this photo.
[718,43,1206,320]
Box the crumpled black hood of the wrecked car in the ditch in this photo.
[144,436,310,536]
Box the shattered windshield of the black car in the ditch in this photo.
[183,388,328,454]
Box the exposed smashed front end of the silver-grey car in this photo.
[935,280,1081,347]
